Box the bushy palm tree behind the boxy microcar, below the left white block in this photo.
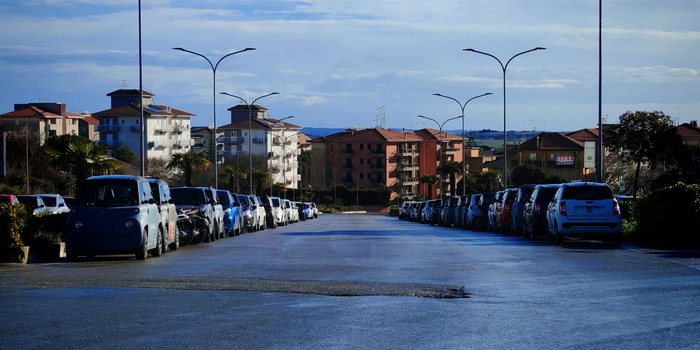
[46,139,121,181]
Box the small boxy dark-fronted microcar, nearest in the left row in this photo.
[65,175,165,260]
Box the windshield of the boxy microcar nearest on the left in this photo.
[76,180,139,207]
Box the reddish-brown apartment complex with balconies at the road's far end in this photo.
[311,128,462,199]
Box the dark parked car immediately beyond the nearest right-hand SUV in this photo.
[523,184,559,239]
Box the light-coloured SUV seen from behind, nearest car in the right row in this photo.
[547,182,622,243]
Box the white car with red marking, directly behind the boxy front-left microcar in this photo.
[148,179,180,253]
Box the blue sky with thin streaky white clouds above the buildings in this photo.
[0,0,700,131]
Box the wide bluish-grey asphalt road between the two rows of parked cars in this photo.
[0,214,700,349]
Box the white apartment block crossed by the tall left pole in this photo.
[94,89,194,159]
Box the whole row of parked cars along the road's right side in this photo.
[399,182,622,243]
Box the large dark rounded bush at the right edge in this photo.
[634,183,700,248]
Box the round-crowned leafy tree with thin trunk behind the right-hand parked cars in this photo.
[605,111,681,198]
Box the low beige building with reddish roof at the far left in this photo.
[0,102,97,145]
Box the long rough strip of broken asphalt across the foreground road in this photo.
[1,277,469,299]
